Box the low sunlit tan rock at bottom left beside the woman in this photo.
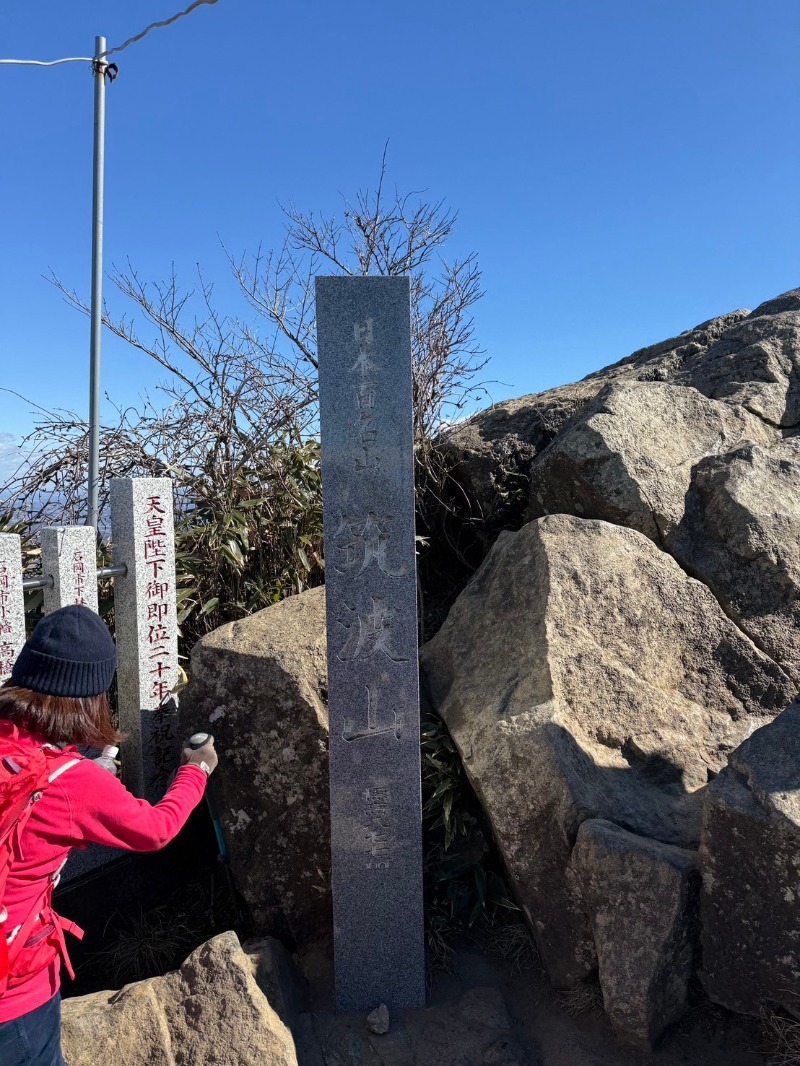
[62,933,298,1066]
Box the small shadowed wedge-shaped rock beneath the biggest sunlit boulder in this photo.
[570,819,698,1050]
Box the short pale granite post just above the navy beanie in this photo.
[39,526,98,614]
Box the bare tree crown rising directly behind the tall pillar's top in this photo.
[228,157,485,442]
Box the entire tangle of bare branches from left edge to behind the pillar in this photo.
[2,164,484,550]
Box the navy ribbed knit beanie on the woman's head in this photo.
[11,604,116,698]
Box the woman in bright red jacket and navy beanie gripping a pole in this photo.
[0,607,217,1066]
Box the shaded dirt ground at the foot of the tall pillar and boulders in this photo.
[295,948,764,1066]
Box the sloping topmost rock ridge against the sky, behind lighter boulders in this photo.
[442,290,800,558]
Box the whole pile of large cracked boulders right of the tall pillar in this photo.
[422,290,800,1046]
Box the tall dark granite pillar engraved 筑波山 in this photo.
[317,277,425,1011]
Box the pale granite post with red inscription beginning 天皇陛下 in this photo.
[111,478,178,801]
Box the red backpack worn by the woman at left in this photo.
[0,730,83,996]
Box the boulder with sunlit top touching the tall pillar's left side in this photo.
[180,588,332,943]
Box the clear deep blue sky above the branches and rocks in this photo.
[0,0,800,475]
